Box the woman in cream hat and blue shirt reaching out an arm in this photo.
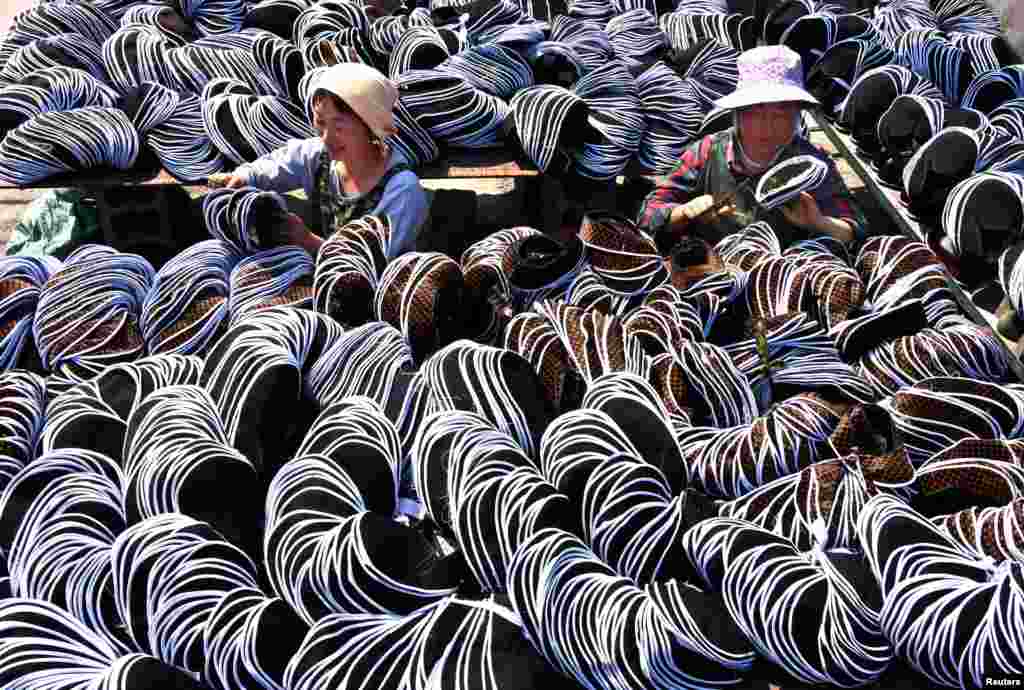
[212,62,428,259]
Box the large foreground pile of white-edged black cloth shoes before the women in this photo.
[0,194,1024,690]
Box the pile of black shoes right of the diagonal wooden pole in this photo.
[790,0,1024,342]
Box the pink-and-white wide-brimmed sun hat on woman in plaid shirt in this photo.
[715,45,819,111]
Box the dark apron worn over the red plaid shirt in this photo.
[694,132,808,249]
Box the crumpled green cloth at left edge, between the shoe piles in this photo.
[7,189,100,259]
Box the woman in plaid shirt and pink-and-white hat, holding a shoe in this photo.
[638,45,863,246]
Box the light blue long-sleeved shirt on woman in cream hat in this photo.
[236,137,429,259]
